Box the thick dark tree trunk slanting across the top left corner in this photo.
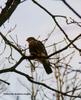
[0,0,20,26]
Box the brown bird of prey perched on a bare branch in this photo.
[26,37,52,74]
